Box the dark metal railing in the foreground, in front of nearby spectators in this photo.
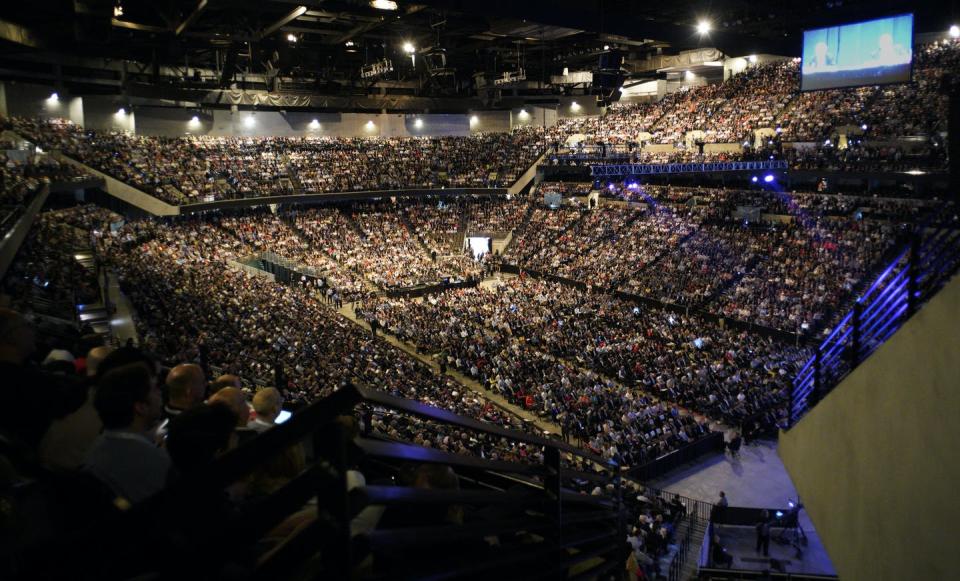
[16,386,630,579]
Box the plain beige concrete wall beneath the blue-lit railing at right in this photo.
[779,277,960,580]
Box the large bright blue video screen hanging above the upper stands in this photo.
[800,14,913,91]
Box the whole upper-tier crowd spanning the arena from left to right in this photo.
[3,40,960,213]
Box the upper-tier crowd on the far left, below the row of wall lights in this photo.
[6,118,543,204]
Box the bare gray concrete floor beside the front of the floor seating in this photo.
[649,441,836,575]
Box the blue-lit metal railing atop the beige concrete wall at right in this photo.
[788,205,960,429]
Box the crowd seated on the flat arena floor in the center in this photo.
[358,277,803,454]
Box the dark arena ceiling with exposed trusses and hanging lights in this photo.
[0,0,960,95]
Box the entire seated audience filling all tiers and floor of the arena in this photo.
[0,35,960,576]
